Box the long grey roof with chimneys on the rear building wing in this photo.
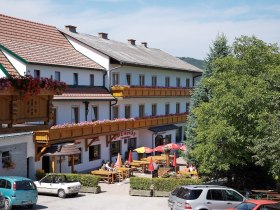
[60,29,202,73]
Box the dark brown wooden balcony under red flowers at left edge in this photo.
[0,88,53,133]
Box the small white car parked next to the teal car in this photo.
[34,174,81,198]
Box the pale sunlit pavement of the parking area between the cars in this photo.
[13,182,169,210]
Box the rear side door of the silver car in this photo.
[206,189,226,210]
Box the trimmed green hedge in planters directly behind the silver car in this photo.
[130,177,201,192]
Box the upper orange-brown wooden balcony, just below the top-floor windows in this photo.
[112,86,191,98]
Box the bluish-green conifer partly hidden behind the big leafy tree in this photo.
[185,34,231,162]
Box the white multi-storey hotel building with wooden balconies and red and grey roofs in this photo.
[0,15,201,177]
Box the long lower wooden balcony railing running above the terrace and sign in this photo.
[34,113,187,143]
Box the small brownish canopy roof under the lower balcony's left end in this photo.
[43,144,81,156]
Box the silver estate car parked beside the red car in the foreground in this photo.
[168,185,246,210]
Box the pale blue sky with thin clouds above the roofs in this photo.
[0,0,280,59]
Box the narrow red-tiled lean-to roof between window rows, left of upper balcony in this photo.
[54,87,115,100]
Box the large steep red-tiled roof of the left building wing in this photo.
[0,14,104,70]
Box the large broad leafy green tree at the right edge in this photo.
[190,36,280,185]
